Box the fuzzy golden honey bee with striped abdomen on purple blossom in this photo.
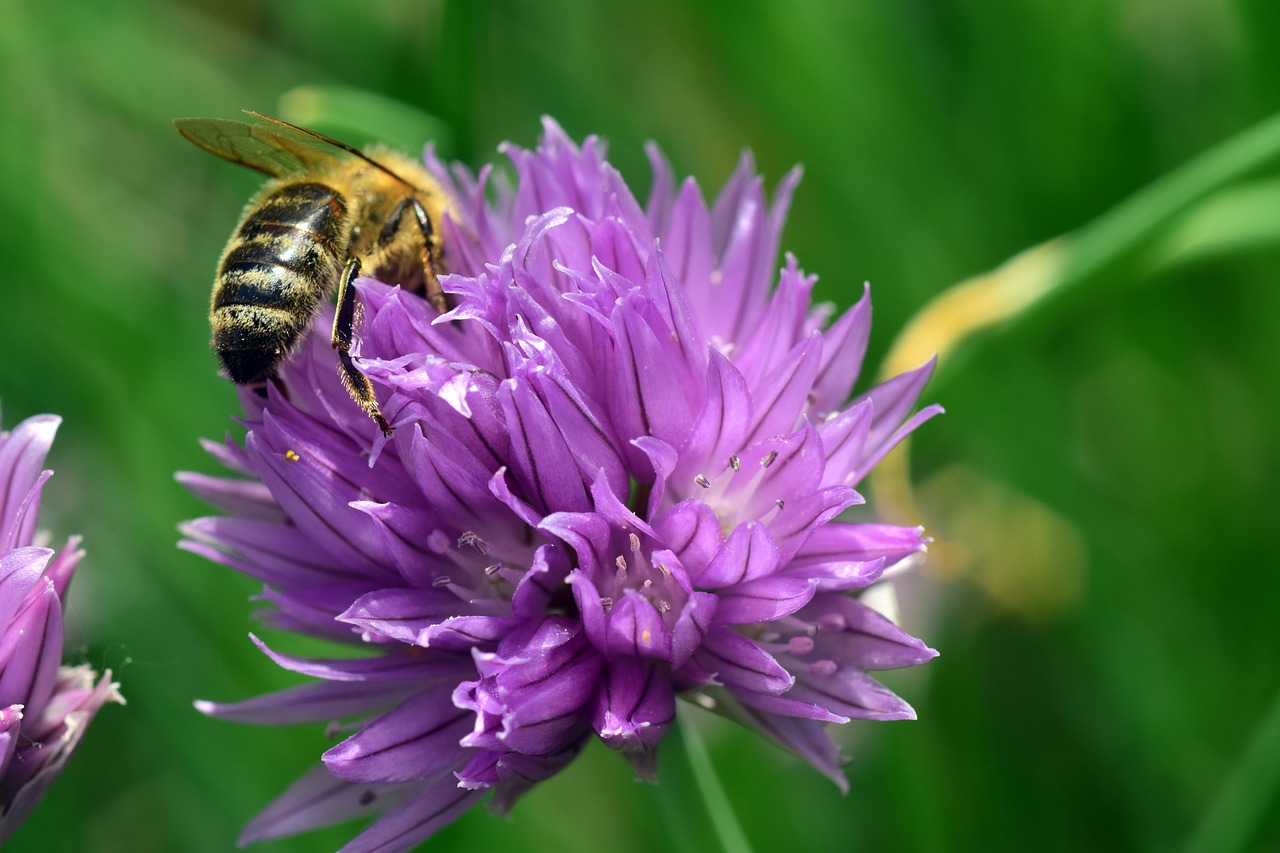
[174,111,447,435]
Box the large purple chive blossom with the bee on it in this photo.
[184,122,940,850]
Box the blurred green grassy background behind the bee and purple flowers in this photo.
[0,0,1280,853]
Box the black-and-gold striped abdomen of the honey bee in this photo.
[211,182,347,383]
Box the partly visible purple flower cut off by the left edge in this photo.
[0,415,123,844]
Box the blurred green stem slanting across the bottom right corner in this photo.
[1187,694,1280,853]
